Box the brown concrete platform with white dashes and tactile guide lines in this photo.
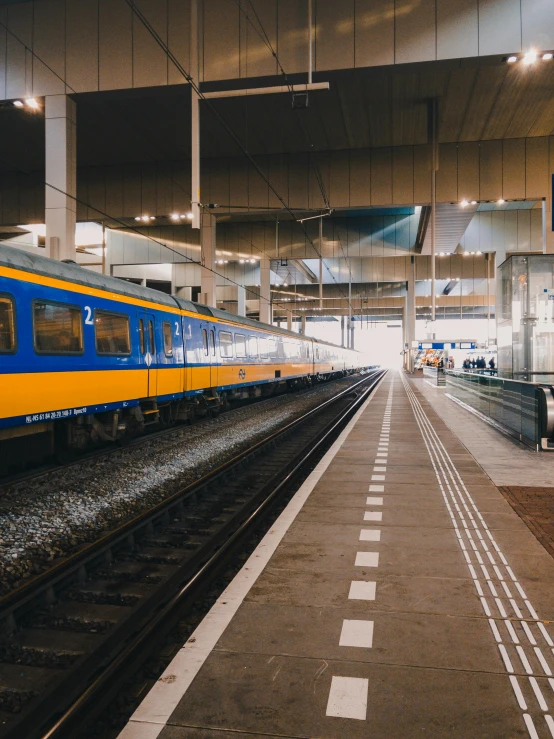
[120,373,554,739]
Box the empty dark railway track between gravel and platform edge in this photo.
[0,371,384,739]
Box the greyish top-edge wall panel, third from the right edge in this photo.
[437,0,479,59]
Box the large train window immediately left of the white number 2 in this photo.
[33,300,83,354]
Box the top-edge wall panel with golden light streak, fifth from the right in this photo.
[354,0,394,67]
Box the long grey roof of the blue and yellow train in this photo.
[0,244,356,347]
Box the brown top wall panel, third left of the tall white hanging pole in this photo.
[98,0,133,90]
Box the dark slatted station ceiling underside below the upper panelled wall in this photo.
[0,57,554,177]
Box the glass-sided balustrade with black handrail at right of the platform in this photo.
[445,370,554,451]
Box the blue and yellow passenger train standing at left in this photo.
[0,246,361,469]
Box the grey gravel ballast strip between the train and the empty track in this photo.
[0,376,366,594]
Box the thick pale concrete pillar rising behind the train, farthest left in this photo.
[45,95,77,260]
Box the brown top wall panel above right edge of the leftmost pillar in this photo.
[65,0,98,92]
